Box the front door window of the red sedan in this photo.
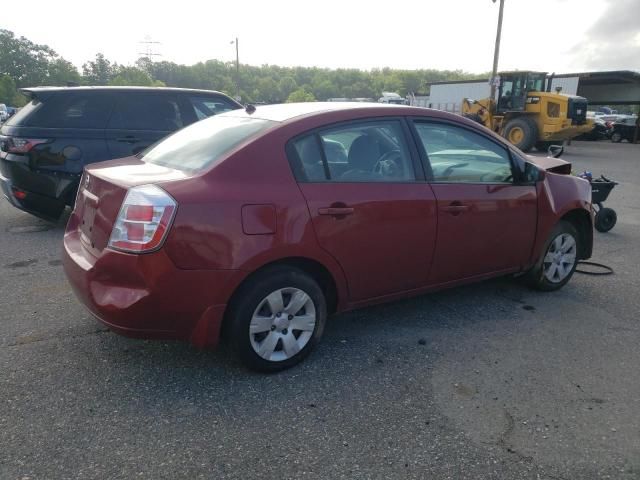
[415,122,513,183]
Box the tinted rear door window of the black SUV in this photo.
[107,92,184,132]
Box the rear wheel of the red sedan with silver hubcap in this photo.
[227,266,327,372]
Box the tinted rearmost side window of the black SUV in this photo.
[9,92,113,128]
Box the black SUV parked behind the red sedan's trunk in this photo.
[0,87,242,220]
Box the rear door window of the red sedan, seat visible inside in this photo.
[294,120,416,182]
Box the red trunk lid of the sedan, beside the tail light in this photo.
[73,157,187,256]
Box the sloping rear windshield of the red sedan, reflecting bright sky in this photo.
[141,116,276,173]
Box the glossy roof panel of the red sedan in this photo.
[219,102,428,122]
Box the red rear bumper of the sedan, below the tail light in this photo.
[63,227,239,347]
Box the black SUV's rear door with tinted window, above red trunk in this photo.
[106,91,185,158]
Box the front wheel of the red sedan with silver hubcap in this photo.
[524,220,581,292]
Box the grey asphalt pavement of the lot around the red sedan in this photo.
[0,142,640,480]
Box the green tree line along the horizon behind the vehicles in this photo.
[0,29,487,106]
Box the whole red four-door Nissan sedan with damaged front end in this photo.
[64,103,593,371]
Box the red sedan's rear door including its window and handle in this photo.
[289,119,436,302]
